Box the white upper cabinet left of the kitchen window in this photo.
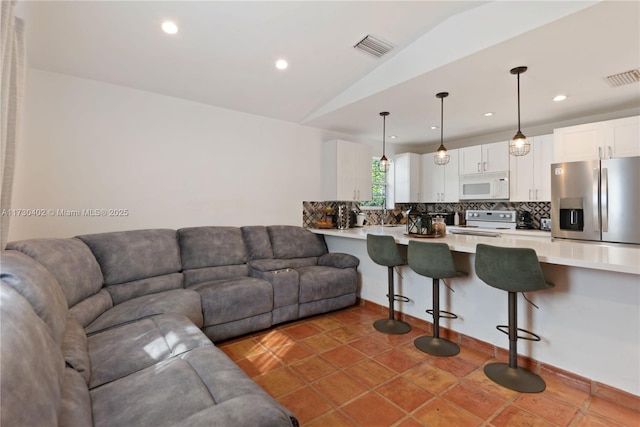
[322,139,373,201]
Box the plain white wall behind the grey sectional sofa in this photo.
[9,69,327,240]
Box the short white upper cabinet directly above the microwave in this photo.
[459,141,509,175]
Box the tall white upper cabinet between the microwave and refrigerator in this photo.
[509,134,553,202]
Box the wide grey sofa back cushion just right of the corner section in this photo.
[78,229,182,304]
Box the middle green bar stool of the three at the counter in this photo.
[409,240,467,356]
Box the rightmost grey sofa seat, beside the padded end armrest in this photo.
[298,266,357,304]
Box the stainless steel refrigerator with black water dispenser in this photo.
[551,157,640,244]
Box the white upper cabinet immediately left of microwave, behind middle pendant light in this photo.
[422,149,461,203]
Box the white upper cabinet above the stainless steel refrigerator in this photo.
[553,116,640,163]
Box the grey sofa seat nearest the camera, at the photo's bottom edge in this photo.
[90,346,293,427]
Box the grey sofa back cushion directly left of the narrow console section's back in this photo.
[178,227,249,287]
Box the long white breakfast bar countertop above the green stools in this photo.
[310,225,640,275]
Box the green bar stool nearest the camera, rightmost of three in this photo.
[475,244,554,393]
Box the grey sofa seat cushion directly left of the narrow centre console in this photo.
[189,277,273,326]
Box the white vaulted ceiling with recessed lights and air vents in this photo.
[21,1,640,150]
